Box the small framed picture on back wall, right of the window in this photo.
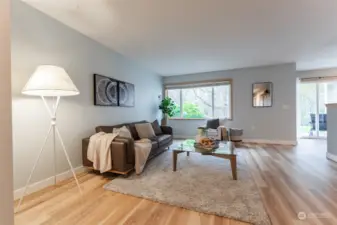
[252,82,273,108]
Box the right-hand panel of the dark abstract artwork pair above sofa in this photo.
[118,81,135,107]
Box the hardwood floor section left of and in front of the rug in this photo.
[15,173,248,225]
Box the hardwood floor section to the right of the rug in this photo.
[241,140,337,225]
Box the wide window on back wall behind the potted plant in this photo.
[166,80,232,119]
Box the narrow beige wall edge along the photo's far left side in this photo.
[0,0,14,222]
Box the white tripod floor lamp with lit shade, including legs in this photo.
[17,65,82,211]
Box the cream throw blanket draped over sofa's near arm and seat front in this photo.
[87,131,152,174]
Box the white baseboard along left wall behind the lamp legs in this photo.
[14,166,87,200]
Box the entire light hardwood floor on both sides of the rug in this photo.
[15,140,337,225]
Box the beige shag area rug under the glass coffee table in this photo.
[104,151,271,225]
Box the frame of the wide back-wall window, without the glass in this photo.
[164,79,233,120]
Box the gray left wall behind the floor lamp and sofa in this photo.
[11,0,162,189]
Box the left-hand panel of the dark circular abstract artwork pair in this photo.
[94,74,119,106]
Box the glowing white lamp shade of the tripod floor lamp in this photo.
[22,65,80,96]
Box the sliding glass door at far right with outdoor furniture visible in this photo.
[297,78,337,138]
